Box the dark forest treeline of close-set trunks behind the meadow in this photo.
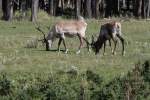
[0,0,150,21]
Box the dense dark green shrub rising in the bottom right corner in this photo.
[91,61,150,100]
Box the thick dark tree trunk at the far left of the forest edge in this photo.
[2,0,14,21]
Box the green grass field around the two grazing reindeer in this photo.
[0,15,150,99]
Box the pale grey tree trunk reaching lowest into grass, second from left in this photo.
[31,0,39,22]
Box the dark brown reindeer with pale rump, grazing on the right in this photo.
[91,22,125,55]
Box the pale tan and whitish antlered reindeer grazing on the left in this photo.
[37,16,89,54]
